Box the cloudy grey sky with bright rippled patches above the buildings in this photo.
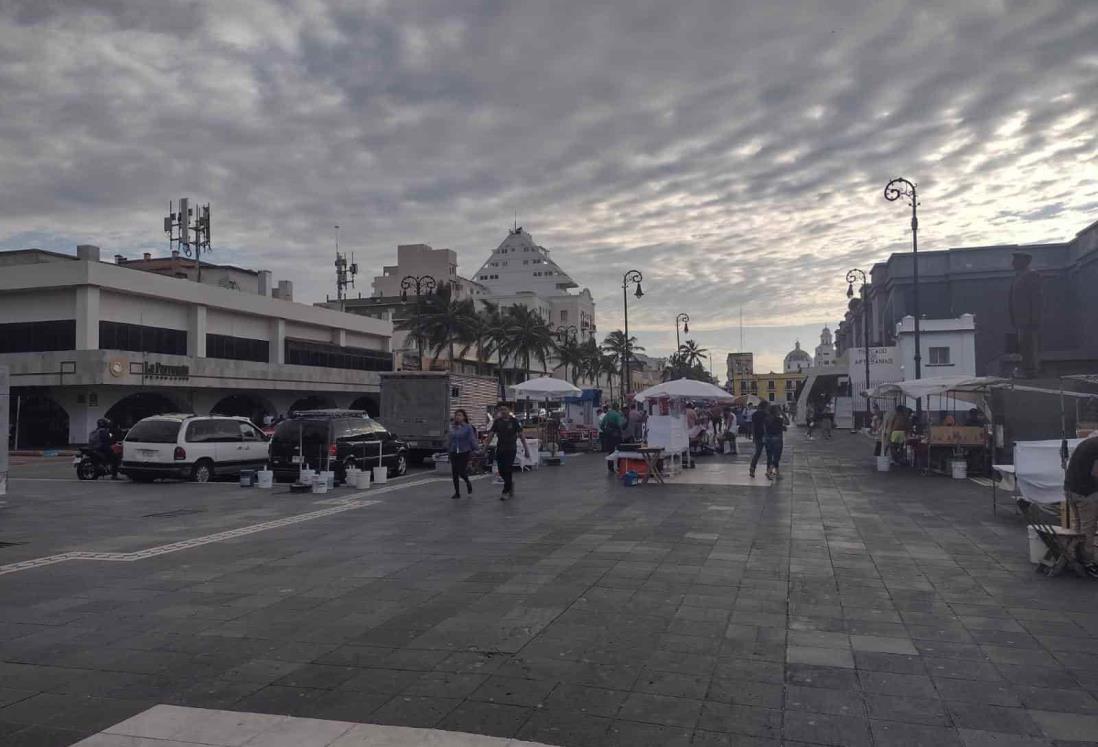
[0,0,1098,368]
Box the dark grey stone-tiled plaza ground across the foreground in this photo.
[0,433,1098,747]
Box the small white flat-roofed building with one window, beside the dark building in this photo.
[891,314,976,381]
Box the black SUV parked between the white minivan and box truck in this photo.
[270,410,408,482]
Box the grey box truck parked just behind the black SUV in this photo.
[378,371,500,462]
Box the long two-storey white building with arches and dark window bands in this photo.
[0,246,392,447]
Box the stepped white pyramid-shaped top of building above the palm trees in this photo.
[473,225,579,297]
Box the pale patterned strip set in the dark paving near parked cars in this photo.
[0,478,448,576]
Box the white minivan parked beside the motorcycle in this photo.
[119,414,269,482]
